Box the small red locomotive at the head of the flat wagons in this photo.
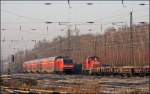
[83,56,102,74]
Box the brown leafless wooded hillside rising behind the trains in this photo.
[15,23,149,70]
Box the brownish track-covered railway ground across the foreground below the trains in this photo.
[0,74,149,94]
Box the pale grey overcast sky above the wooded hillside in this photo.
[1,0,149,57]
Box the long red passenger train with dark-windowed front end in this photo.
[23,56,74,73]
